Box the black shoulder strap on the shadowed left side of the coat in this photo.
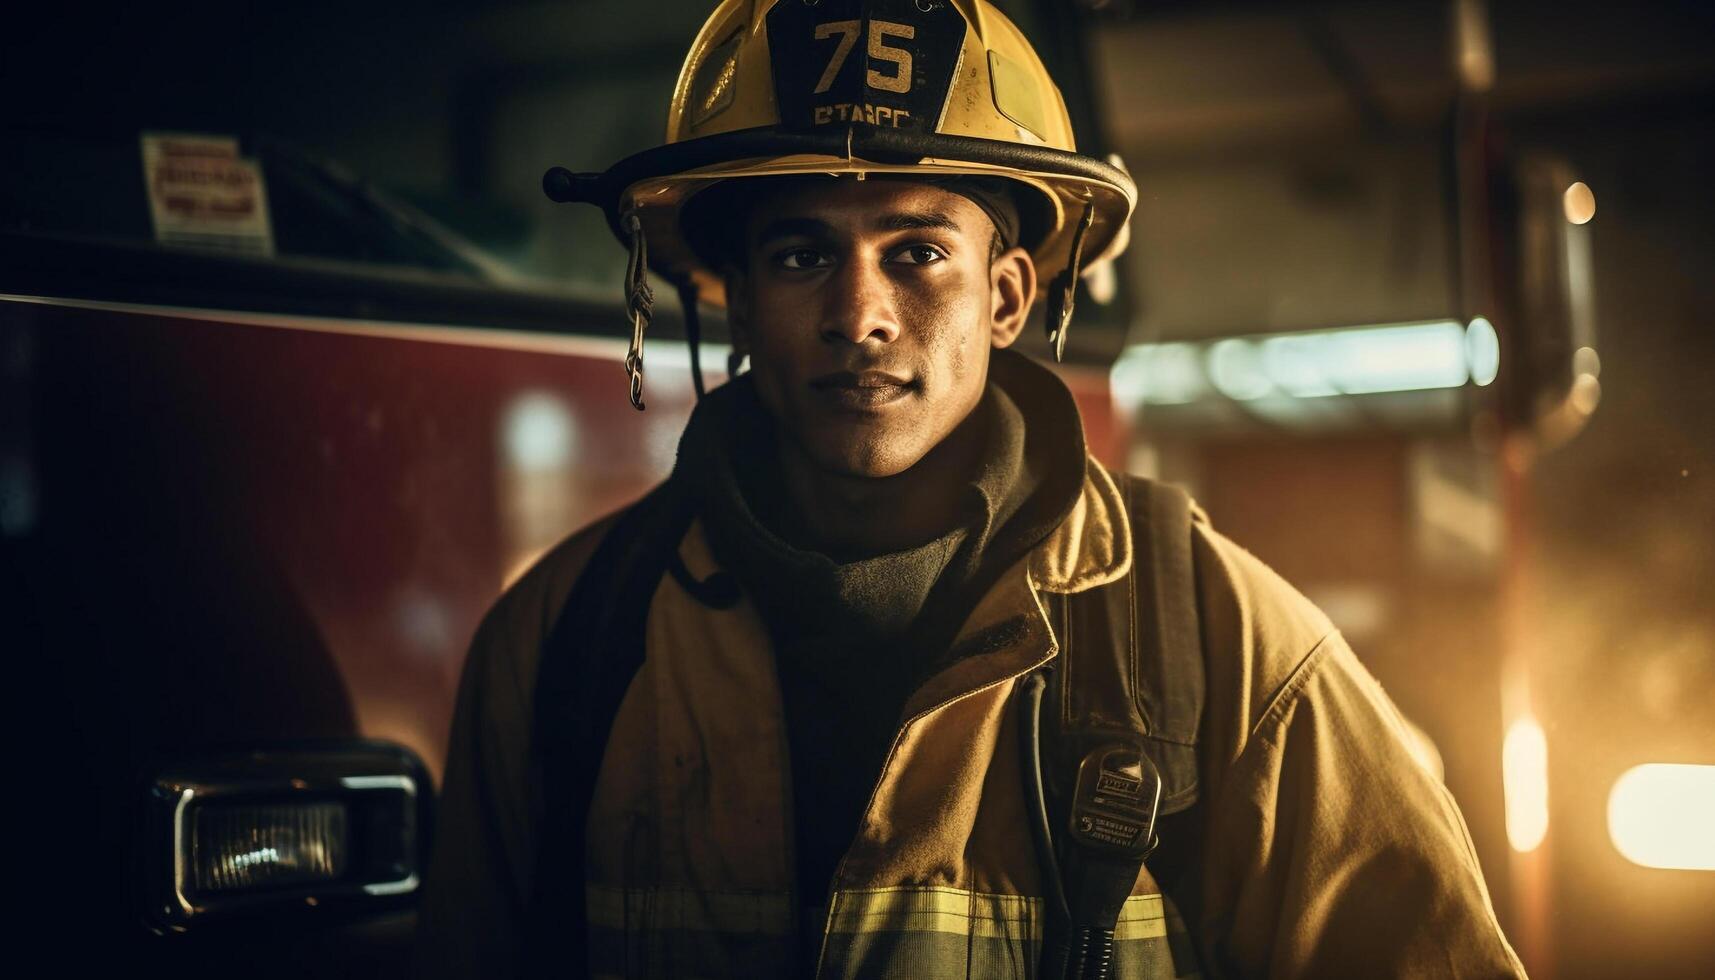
[527,481,693,977]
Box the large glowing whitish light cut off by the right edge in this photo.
[1609,762,1715,872]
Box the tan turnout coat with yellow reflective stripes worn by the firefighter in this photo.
[418,460,1523,978]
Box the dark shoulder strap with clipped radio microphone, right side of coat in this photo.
[1022,475,1204,977]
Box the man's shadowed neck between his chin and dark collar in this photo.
[779,408,984,561]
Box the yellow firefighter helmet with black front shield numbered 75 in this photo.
[544,0,1137,407]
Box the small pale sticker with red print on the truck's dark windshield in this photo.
[142,132,274,256]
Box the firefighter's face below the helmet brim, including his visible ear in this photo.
[727,178,1036,477]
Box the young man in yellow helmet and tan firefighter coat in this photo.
[420,0,1521,977]
